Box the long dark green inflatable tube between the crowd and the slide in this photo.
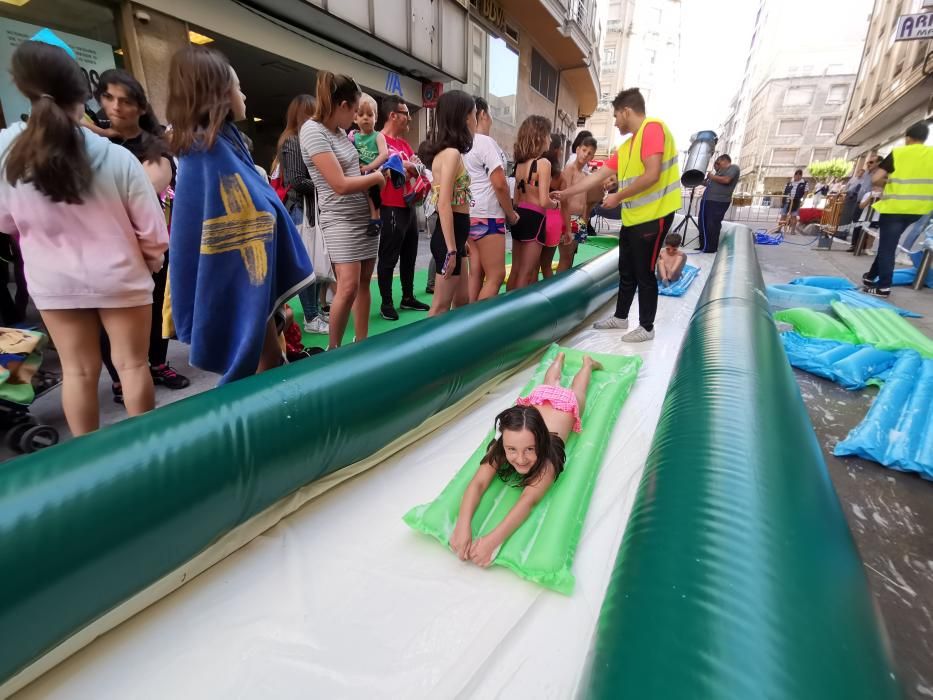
[0,250,618,682]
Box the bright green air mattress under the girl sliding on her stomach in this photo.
[404,345,641,594]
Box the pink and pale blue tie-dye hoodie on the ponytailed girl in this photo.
[0,122,168,310]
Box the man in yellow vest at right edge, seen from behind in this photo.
[862,122,933,297]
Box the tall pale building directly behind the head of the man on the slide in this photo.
[587,0,682,156]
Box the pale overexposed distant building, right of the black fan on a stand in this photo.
[717,0,872,194]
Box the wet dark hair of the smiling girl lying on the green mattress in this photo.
[483,406,567,486]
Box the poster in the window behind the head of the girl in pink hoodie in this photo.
[0,18,116,125]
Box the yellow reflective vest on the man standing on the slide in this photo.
[618,117,680,226]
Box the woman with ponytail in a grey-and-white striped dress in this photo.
[299,70,386,348]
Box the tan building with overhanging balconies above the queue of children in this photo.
[446,0,601,160]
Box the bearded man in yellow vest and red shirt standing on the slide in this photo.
[553,88,681,343]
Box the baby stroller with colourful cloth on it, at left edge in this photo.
[0,327,60,453]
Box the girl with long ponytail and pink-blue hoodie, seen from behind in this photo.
[0,41,168,435]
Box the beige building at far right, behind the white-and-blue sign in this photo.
[839,0,933,158]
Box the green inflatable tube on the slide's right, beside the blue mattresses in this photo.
[580,225,902,700]
